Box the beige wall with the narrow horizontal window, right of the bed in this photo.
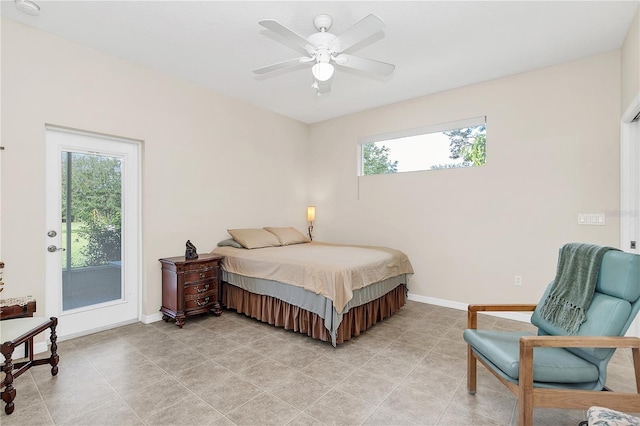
[310,52,620,303]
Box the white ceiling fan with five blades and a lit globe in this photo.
[253,15,395,95]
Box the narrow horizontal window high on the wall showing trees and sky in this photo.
[358,117,487,176]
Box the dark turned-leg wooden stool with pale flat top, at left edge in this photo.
[0,317,59,414]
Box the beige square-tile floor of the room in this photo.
[0,301,634,426]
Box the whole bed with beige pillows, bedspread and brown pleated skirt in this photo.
[213,228,413,346]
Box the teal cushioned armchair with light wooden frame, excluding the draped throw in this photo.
[463,250,640,426]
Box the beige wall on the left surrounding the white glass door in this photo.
[1,19,308,315]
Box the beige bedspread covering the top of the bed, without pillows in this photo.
[213,242,413,312]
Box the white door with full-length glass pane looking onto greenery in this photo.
[44,126,140,338]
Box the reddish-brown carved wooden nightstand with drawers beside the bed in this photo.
[159,254,223,328]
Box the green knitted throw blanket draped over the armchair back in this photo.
[540,243,617,334]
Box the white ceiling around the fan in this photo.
[1,0,639,123]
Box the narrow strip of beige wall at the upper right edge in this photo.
[620,7,640,113]
